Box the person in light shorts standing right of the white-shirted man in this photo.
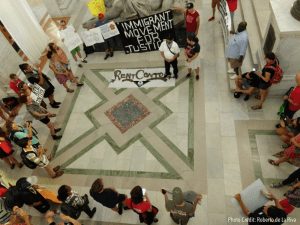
[184,34,200,80]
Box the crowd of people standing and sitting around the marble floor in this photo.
[0,0,300,225]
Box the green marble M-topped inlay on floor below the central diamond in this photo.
[62,134,182,179]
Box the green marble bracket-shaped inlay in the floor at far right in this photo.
[248,130,281,185]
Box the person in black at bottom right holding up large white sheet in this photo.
[234,193,287,225]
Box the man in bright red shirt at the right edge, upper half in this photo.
[283,72,300,119]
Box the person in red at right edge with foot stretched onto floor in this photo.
[268,134,300,166]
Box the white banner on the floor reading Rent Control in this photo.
[105,68,175,88]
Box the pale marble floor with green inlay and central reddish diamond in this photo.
[1,0,300,225]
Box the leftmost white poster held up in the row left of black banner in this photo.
[60,26,82,51]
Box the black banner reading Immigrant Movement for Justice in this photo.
[117,10,175,54]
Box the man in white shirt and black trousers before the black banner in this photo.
[159,34,180,79]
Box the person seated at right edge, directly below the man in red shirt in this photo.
[276,117,300,148]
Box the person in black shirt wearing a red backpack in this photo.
[251,52,278,110]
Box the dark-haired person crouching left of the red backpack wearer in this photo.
[234,71,259,101]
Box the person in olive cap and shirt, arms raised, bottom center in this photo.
[161,187,202,225]
